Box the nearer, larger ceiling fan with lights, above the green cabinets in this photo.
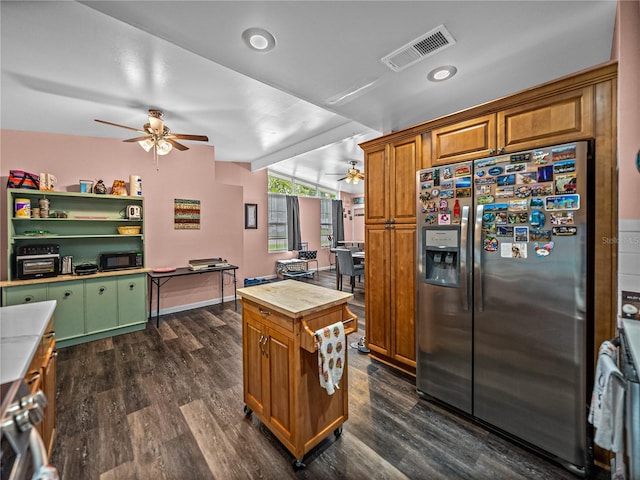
[95,109,209,169]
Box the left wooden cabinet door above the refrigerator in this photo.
[431,114,496,167]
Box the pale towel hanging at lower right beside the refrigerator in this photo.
[589,341,625,452]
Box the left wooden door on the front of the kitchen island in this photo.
[242,316,266,415]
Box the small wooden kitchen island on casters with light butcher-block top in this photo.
[238,280,358,469]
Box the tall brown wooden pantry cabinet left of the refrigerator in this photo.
[363,135,422,374]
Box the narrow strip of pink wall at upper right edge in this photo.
[614,0,640,220]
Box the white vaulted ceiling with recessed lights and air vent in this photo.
[0,0,616,193]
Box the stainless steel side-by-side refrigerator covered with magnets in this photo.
[416,142,593,473]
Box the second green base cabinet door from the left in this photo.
[48,280,85,341]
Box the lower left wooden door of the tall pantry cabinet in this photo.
[364,225,391,356]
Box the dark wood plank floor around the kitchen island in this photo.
[51,271,606,480]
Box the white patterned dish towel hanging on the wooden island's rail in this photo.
[316,322,346,395]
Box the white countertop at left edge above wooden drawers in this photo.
[0,300,56,385]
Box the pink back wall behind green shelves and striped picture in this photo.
[0,130,346,309]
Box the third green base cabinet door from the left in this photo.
[85,277,118,333]
